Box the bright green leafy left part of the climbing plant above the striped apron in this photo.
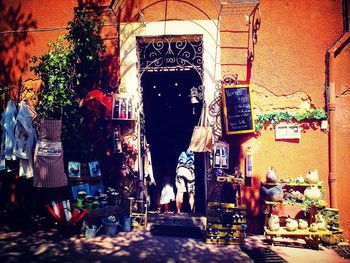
[31,39,76,119]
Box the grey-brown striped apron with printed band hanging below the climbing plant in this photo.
[33,120,68,188]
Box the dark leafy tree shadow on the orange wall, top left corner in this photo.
[0,1,37,96]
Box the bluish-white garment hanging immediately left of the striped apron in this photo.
[13,101,36,178]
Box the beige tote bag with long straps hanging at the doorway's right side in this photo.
[189,102,213,152]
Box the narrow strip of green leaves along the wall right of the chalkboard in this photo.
[255,109,327,131]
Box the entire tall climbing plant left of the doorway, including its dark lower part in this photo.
[31,10,105,161]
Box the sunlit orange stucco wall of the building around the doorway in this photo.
[0,0,350,238]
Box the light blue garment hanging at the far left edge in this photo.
[0,100,17,160]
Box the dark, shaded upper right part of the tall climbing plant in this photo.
[66,9,106,98]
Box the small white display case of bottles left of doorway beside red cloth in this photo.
[112,94,133,120]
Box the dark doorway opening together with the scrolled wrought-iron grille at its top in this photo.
[137,35,205,212]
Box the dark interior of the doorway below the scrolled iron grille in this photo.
[141,69,205,212]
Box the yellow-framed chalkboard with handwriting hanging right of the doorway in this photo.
[222,85,255,134]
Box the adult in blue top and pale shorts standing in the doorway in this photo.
[175,149,195,213]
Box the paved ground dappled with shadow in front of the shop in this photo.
[0,226,350,263]
